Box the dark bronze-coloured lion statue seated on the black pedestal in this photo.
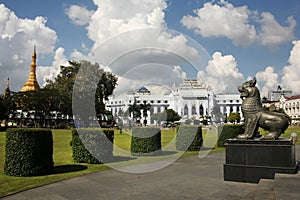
[237,77,291,140]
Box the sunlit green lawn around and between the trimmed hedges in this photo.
[0,128,300,198]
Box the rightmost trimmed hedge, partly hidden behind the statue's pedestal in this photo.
[217,124,245,147]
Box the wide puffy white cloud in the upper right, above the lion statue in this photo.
[181,0,296,47]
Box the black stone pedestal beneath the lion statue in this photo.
[224,138,298,183]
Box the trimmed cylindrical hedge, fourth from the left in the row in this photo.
[176,125,203,151]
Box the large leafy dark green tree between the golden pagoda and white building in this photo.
[45,61,118,126]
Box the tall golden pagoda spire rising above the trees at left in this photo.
[21,46,40,92]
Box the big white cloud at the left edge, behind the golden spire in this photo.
[0,4,57,91]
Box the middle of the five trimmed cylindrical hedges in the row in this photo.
[131,127,161,155]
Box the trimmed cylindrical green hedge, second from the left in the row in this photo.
[71,128,114,164]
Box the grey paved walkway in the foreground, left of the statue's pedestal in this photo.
[3,148,300,200]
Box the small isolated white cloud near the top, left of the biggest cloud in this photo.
[65,5,94,26]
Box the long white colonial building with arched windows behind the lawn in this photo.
[106,79,242,124]
